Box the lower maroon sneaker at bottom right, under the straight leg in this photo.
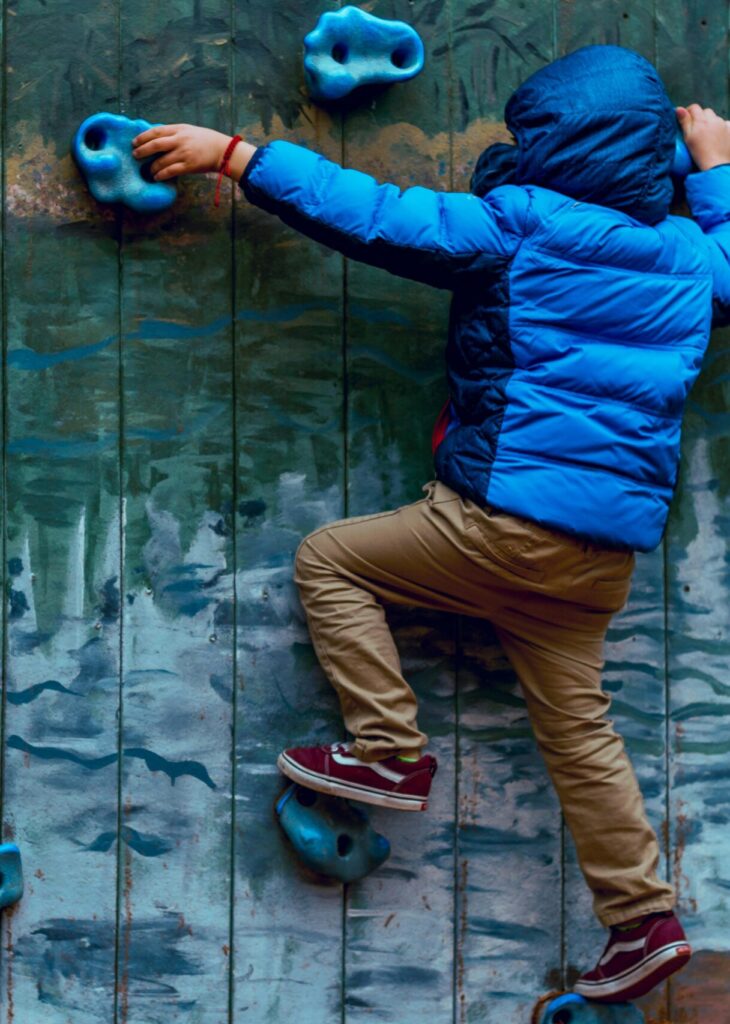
[573,910,692,1002]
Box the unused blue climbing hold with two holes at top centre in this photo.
[304,7,424,100]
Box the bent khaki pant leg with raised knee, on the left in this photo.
[295,483,511,761]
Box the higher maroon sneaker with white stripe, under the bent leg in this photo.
[276,743,436,811]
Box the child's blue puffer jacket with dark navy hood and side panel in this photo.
[242,46,730,551]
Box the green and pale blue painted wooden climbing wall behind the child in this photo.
[0,0,730,1024]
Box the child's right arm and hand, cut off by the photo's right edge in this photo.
[677,103,730,325]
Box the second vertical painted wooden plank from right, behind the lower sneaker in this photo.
[557,6,667,1015]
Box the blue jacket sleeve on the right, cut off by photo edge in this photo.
[685,164,730,327]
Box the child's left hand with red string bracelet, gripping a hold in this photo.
[132,125,255,181]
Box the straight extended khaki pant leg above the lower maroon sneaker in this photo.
[498,602,675,926]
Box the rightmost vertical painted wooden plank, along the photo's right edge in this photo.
[657,0,730,1024]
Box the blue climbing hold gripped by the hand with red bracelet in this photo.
[74,114,177,213]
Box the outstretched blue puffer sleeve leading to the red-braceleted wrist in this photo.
[241,141,529,289]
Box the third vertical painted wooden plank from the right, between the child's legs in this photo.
[454,0,562,1024]
